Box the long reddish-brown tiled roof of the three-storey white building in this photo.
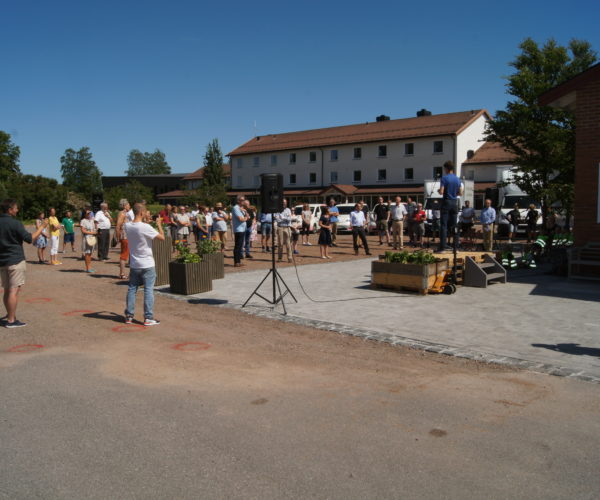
[227,109,491,156]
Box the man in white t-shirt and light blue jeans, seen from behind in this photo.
[125,203,165,326]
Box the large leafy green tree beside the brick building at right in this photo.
[486,38,596,224]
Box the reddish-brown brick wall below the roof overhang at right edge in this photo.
[574,80,600,246]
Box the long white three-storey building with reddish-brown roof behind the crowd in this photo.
[228,110,491,206]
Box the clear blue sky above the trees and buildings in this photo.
[0,0,600,178]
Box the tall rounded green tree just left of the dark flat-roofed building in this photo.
[60,147,102,200]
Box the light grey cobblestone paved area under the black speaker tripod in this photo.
[159,259,600,383]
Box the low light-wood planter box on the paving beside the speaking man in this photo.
[371,259,448,295]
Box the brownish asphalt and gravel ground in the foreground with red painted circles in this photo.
[0,240,600,499]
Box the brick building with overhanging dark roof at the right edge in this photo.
[539,64,600,246]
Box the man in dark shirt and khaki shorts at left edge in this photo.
[0,198,48,328]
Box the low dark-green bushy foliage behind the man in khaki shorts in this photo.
[10,175,74,219]
